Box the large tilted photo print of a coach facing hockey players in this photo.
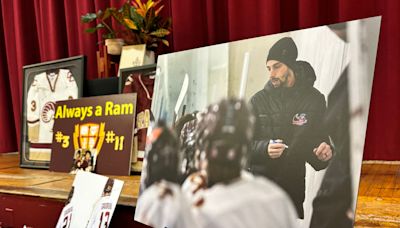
[135,17,380,227]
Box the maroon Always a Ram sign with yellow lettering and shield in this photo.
[50,93,136,175]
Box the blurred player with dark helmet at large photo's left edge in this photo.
[135,123,197,228]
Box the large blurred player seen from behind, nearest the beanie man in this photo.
[190,99,296,228]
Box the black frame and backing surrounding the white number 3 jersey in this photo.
[20,55,85,169]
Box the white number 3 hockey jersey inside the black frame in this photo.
[26,69,78,144]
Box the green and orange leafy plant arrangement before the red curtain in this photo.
[81,0,171,51]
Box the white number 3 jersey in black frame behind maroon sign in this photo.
[20,56,84,168]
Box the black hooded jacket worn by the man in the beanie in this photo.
[249,65,329,218]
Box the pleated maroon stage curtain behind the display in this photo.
[0,0,400,160]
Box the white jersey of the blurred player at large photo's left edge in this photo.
[135,181,199,228]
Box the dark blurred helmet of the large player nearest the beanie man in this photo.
[196,98,255,165]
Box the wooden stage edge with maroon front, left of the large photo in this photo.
[0,153,146,227]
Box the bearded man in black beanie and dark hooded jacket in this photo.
[249,37,332,218]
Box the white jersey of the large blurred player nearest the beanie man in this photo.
[194,174,297,228]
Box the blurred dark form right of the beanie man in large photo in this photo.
[310,68,353,228]
